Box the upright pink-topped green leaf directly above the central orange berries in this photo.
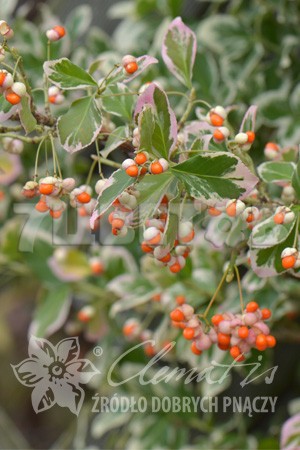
[134,83,177,159]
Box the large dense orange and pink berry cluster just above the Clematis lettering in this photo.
[170,301,276,361]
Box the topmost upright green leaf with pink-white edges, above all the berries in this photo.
[162,17,197,88]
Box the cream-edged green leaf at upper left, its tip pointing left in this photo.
[44,58,98,90]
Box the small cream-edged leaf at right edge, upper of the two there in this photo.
[257,161,296,184]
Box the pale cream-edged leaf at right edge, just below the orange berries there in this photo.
[251,217,295,248]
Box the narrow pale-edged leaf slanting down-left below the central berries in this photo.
[96,169,134,216]
